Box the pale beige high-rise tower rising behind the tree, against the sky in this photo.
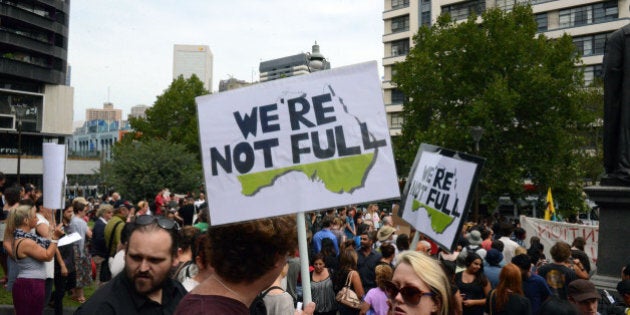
[173,45,213,92]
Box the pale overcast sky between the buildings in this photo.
[68,0,383,122]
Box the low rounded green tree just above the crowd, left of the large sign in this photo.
[101,139,202,200]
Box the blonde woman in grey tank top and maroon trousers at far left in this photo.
[7,205,63,315]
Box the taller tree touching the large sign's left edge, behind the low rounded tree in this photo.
[127,74,209,160]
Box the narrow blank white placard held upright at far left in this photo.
[42,143,67,209]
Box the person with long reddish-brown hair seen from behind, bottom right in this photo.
[485,263,532,315]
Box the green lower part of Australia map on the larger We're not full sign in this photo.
[238,152,375,196]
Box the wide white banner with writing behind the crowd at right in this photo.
[520,216,599,268]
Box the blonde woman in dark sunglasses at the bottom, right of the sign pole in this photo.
[385,251,453,315]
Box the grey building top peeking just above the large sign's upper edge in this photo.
[258,42,330,82]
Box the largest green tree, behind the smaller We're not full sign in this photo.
[393,6,594,215]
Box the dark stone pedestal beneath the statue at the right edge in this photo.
[584,186,630,290]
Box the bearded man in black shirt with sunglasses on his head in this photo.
[75,216,186,315]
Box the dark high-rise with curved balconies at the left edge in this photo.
[0,0,98,185]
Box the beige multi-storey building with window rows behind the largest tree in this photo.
[383,0,630,135]
